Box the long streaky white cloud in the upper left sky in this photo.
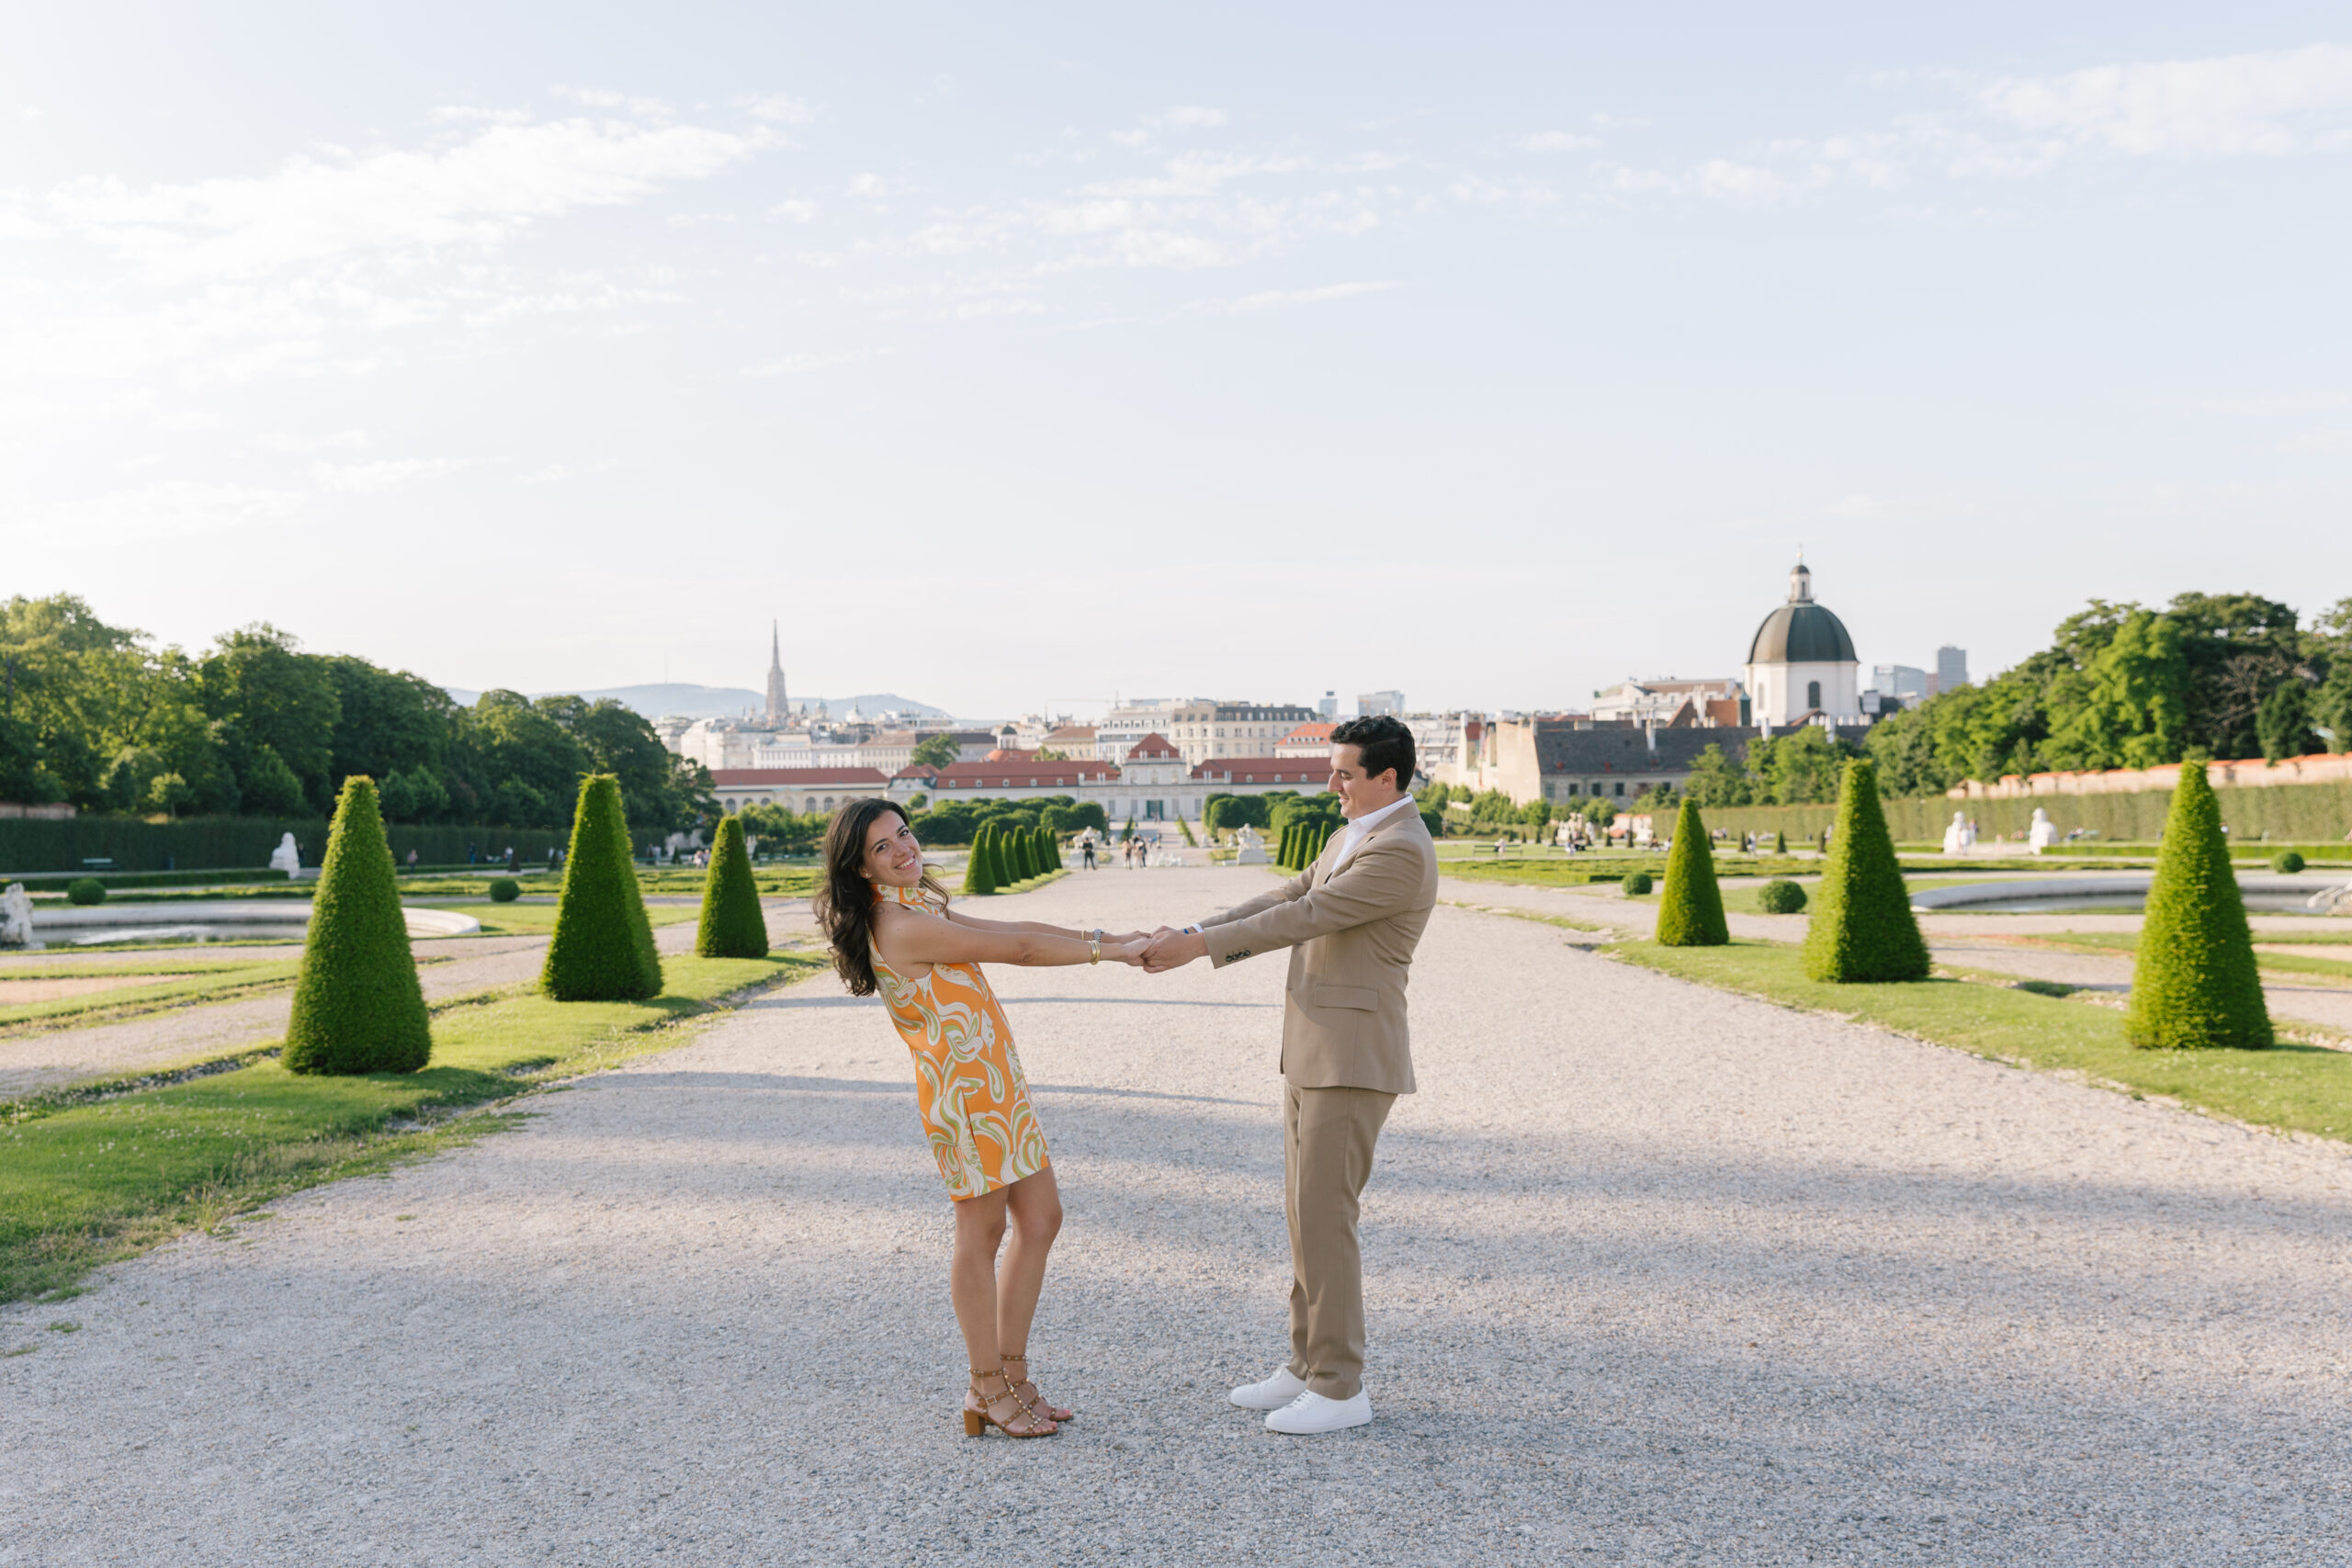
[50,120,764,280]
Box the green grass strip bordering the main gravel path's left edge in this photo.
[0,954,820,1303]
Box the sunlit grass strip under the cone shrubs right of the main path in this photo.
[1609,941,2352,1140]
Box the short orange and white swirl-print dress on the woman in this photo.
[873,886,1046,1199]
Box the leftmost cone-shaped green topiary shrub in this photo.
[282,773,433,1072]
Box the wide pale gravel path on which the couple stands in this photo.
[0,870,2352,1565]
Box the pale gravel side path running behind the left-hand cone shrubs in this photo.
[0,921,766,1098]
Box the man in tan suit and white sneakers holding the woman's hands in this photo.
[1143,715,1437,1434]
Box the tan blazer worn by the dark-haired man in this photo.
[1202,807,1437,1096]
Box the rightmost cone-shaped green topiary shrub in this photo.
[2124,760,2275,1051]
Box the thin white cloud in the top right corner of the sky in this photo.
[1981,45,2352,157]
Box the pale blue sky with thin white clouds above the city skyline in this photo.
[0,0,2352,717]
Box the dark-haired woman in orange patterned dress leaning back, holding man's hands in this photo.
[816,799,1143,1437]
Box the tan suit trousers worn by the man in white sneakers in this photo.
[1282,1084,1397,1399]
